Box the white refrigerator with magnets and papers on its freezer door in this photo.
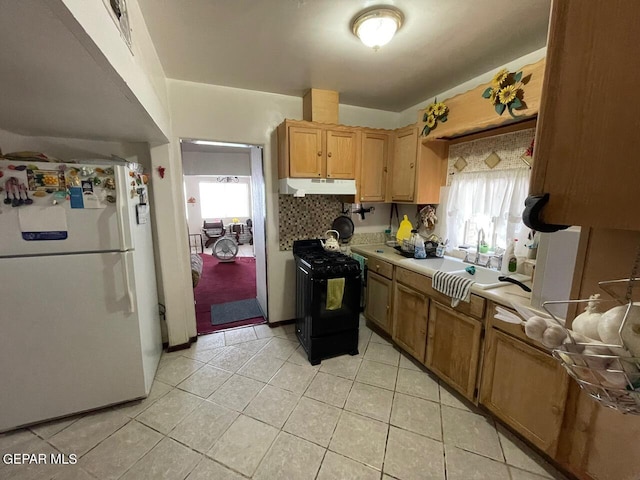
[0,160,162,432]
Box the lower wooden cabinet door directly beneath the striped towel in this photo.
[426,301,482,401]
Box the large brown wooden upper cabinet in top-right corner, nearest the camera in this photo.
[530,0,640,230]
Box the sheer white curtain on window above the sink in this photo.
[445,168,530,249]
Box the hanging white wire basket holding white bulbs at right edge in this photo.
[542,276,640,415]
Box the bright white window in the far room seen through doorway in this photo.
[199,182,251,218]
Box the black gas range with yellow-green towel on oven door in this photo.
[293,239,361,365]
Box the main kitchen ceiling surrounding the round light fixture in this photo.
[138,0,551,112]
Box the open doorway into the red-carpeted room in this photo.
[180,139,267,335]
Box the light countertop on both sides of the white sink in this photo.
[351,244,532,308]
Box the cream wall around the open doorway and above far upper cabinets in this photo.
[167,80,398,322]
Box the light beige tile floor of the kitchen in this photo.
[0,316,563,480]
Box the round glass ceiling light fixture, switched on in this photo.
[352,6,404,50]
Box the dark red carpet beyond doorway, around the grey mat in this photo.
[193,253,265,335]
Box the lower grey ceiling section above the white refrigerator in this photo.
[0,0,166,143]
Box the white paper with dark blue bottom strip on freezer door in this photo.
[18,205,68,241]
